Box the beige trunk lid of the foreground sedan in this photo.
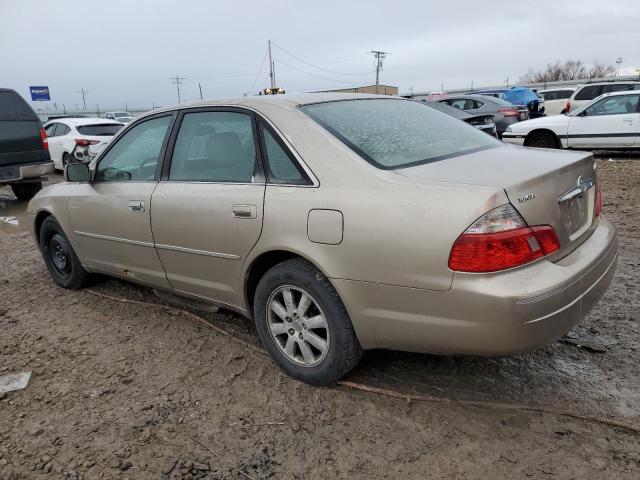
[396,145,596,261]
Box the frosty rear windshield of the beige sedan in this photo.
[300,99,501,170]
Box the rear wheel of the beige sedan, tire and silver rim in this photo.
[253,259,363,385]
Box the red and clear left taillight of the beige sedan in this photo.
[449,204,560,273]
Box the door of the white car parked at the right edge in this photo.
[567,94,640,148]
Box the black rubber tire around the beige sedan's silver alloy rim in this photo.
[253,258,363,385]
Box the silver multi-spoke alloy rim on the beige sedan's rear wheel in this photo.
[267,285,331,367]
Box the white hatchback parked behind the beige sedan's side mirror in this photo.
[44,118,123,170]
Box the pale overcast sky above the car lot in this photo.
[0,0,640,110]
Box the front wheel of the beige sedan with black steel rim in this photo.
[40,217,89,290]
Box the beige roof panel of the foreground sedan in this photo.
[141,93,398,117]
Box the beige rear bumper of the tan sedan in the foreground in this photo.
[332,217,618,356]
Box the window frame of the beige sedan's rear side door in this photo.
[158,105,266,185]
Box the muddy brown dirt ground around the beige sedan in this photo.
[0,155,640,480]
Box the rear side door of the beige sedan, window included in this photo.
[151,107,265,305]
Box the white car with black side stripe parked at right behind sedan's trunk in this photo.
[502,90,640,149]
